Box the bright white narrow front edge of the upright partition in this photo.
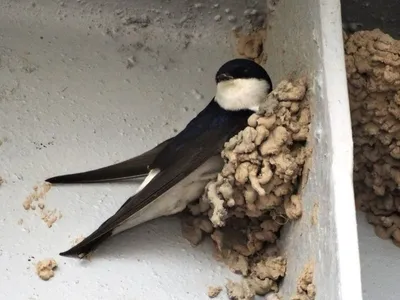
[317,0,362,300]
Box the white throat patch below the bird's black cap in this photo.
[215,78,270,111]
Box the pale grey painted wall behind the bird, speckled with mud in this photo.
[0,0,262,300]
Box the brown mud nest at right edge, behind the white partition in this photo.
[345,29,400,247]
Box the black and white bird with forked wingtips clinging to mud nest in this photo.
[45,58,272,258]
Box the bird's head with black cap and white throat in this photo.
[215,58,272,111]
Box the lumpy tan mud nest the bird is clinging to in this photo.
[182,78,311,300]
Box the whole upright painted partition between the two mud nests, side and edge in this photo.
[266,0,362,300]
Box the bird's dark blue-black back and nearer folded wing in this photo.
[61,101,251,256]
